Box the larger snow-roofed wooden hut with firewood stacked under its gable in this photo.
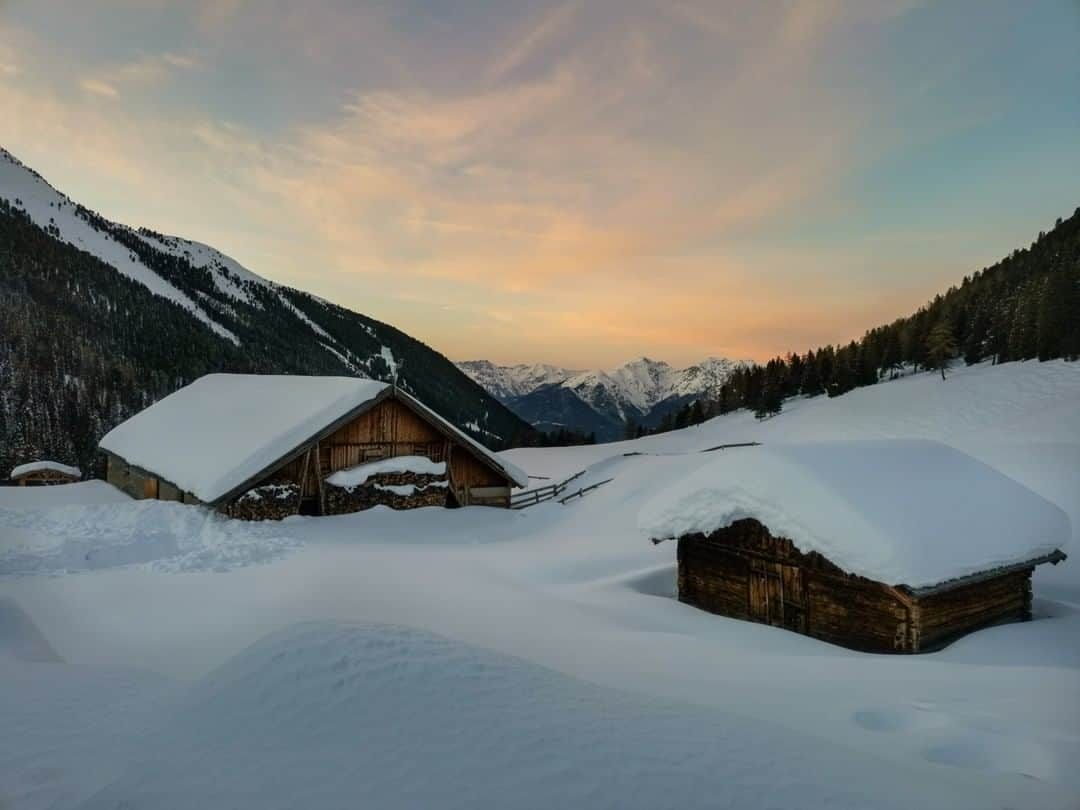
[100,374,528,518]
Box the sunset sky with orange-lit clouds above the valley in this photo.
[0,0,1080,367]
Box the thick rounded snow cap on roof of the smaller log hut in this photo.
[638,440,1071,589]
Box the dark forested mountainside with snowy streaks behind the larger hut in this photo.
[0,149,535,475]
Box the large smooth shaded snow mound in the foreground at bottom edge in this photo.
[82,622,989,810]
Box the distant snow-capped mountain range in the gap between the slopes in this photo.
[457,357,744,441]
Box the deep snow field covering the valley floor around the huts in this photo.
[0,362,1080,810]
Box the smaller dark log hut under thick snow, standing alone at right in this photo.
[638,440,1071,652]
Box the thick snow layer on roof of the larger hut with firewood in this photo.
[100,374,387,502]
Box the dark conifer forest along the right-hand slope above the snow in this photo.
[627,208,1080,435]
